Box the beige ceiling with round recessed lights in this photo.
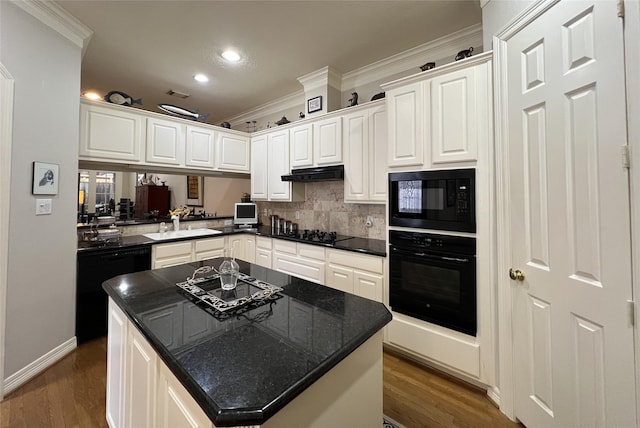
[56,0,481,124]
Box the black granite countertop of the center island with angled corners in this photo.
[103,259,391,426]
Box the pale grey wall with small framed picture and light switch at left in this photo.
[0,1,82,378]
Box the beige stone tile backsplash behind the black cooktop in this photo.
[257,181,386,239]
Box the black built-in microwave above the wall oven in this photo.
[389,168,476,232]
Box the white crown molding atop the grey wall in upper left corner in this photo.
[11,0,93,56]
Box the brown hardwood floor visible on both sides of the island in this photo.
[0,339,521,428]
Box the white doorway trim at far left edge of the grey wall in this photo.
[0,63,14,401]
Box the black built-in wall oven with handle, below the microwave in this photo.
[389,230,477,336]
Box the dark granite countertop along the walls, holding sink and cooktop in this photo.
[78,226,387,257]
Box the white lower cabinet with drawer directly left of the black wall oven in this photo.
[326,249,384,302]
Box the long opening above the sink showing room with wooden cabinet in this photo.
[77,169,251,224]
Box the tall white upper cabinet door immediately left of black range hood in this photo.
[267,130,291,201]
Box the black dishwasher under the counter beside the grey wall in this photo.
[76,245,151,343]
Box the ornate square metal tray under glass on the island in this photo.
[176,268,283,313]
